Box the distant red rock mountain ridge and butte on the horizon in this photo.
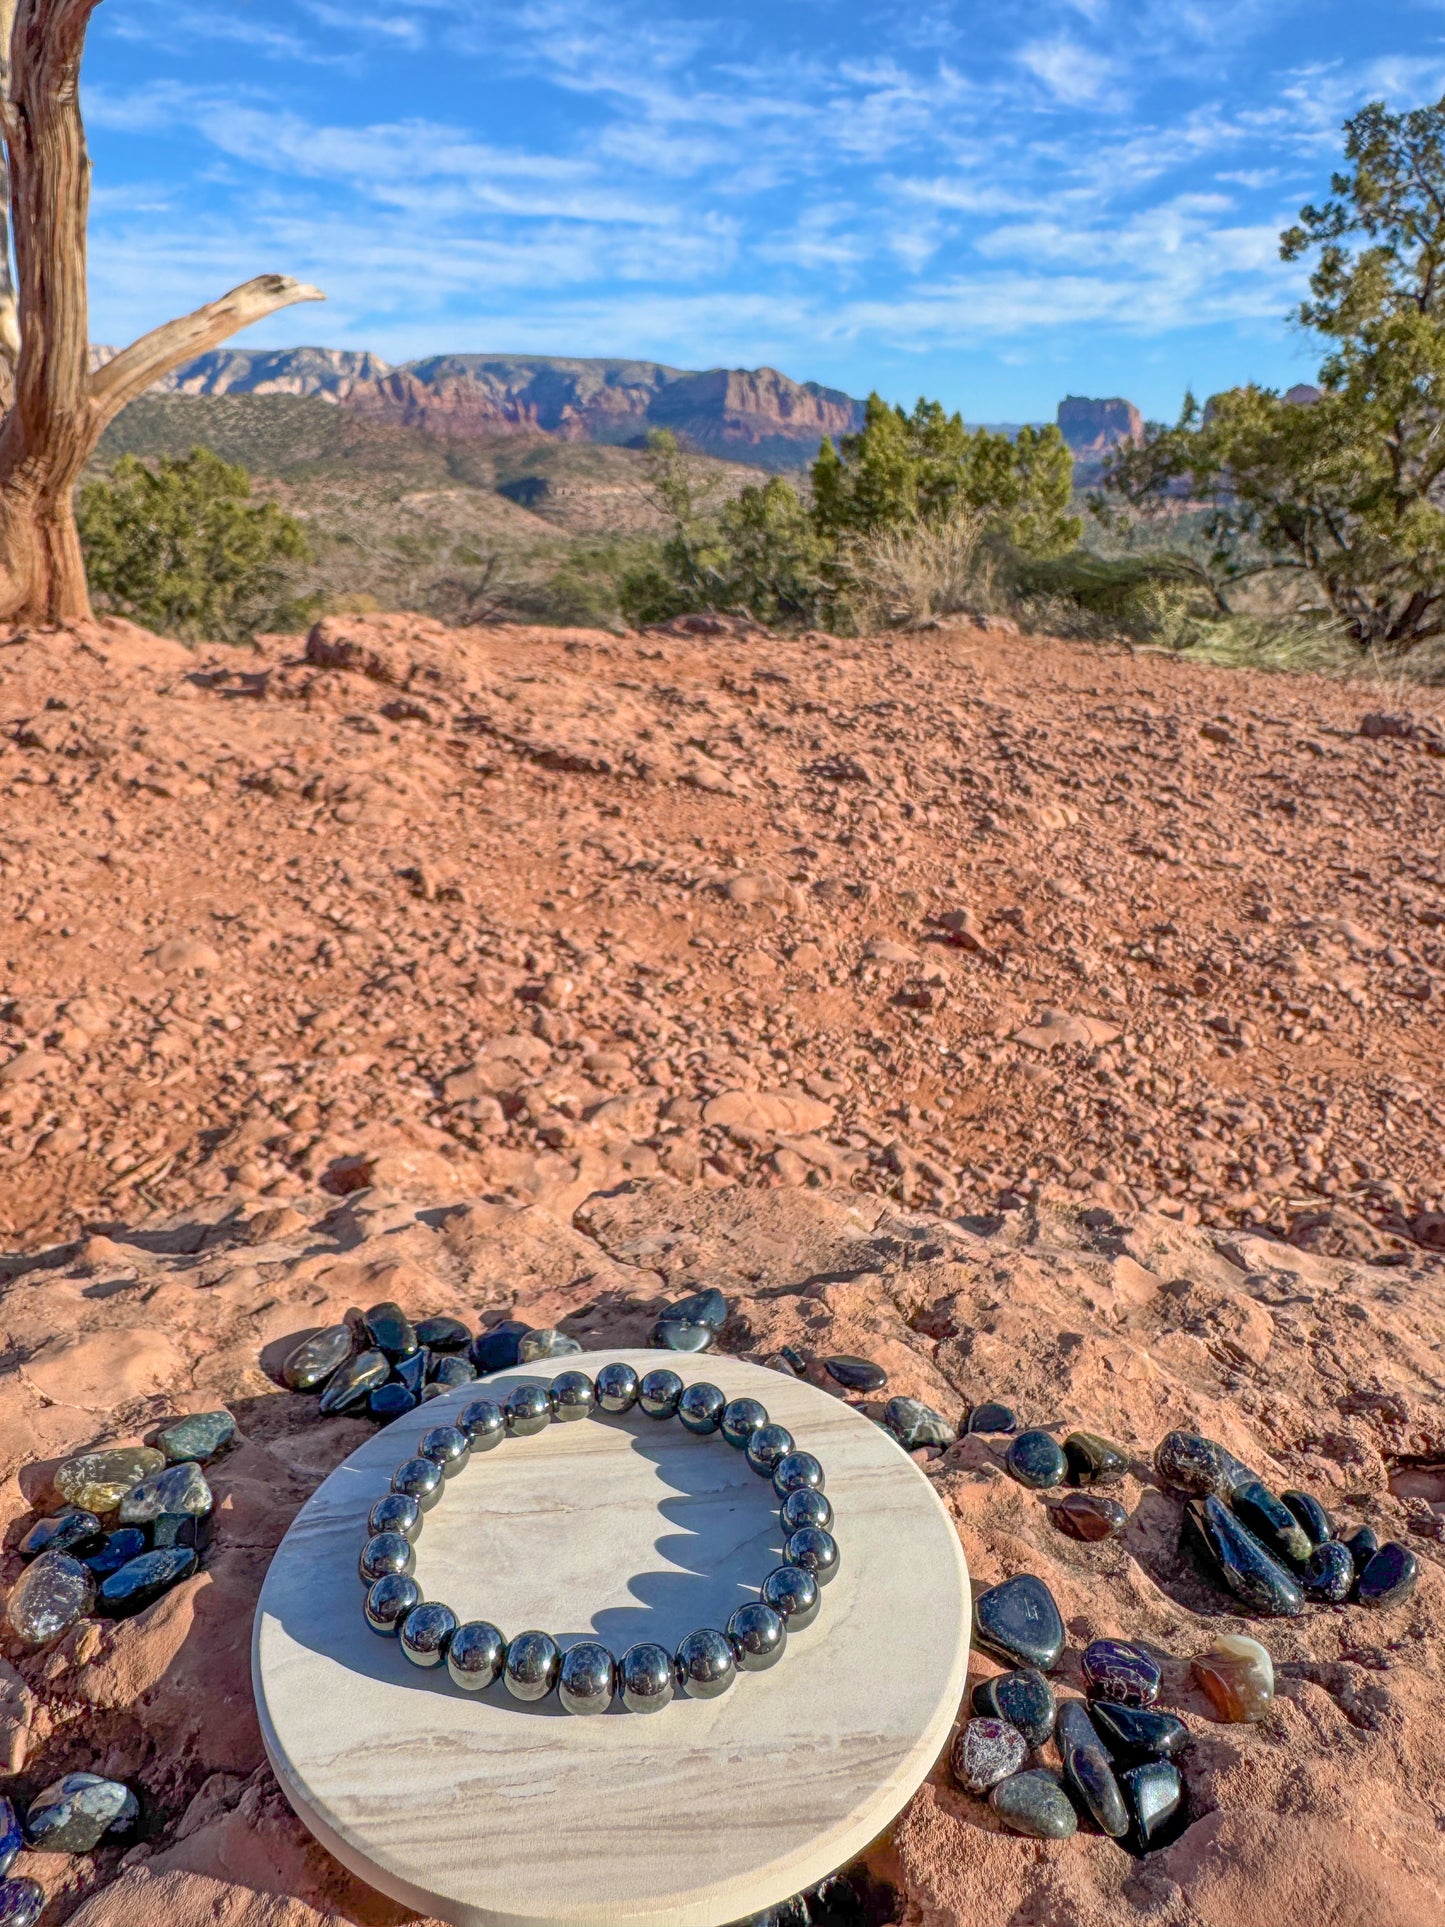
[91,347,1137,468]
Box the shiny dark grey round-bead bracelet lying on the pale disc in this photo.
[358,1364,838,1713]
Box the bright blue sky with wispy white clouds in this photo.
[83,0,1445,420]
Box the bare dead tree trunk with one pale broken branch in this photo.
[0,0,324,622]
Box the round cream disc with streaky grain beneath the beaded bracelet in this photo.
[252,1351,969,1927]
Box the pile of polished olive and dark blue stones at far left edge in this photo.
[6,1411,235,1648]
